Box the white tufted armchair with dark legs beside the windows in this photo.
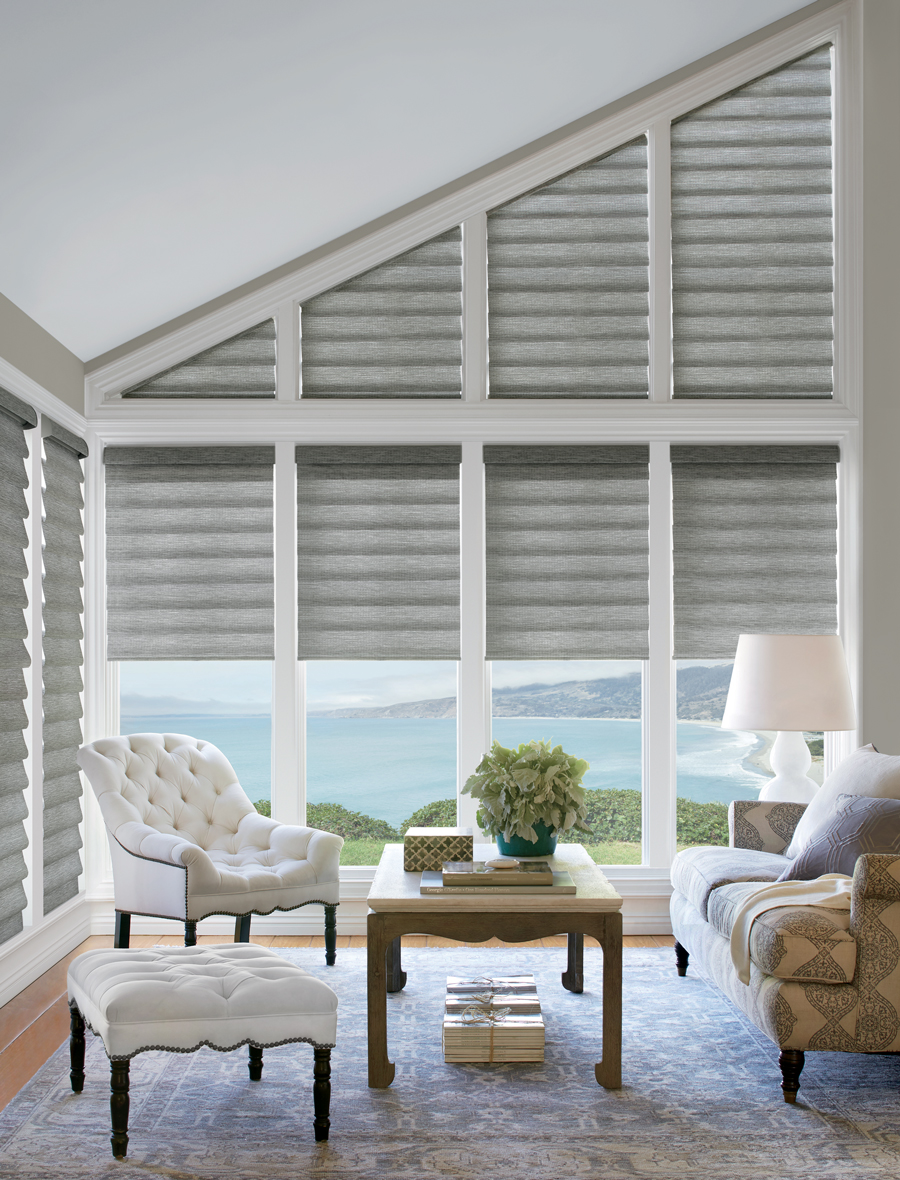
[77,734,343,966]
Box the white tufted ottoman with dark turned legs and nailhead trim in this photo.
[68,943,337,1159]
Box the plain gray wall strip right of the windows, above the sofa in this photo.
[861,0,900,754]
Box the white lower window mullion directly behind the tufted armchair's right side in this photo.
[271,441,307,824]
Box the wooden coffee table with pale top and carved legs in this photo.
[368,844,622,1089]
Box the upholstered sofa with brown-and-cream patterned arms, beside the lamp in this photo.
[671,747,900,1102]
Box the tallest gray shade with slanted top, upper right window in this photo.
[671,45,834,398]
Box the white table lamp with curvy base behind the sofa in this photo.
[722,635,856,804]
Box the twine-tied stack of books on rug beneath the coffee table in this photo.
[442,975,544,1062]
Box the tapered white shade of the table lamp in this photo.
[722,635,856,730]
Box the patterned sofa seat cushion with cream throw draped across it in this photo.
[707,881,856,983]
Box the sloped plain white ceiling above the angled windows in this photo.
[0,0,804,360]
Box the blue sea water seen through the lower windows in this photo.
[121,716,764,826]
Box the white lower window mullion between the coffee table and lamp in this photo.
[643,443,676,868]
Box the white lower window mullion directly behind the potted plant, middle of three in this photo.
[456,443,491,840]
